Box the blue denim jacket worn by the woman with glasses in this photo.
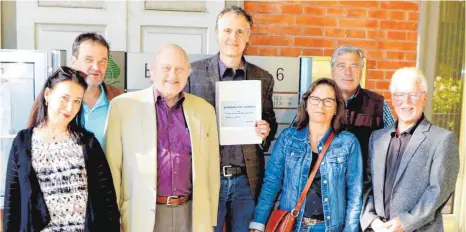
[249,127,363,232]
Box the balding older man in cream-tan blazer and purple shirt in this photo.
[105,44,220,232]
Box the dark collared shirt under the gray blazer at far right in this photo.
[384,115,424,219]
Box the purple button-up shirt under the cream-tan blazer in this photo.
[154,86,192,196]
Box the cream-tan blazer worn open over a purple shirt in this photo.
[105,86,220,232]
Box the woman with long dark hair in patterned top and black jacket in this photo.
[3,66,120,232]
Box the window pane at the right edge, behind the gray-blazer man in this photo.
[432,1,465,214]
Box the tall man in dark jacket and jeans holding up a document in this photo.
[186,6,277,232]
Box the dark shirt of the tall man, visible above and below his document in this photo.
[218,57,247,167]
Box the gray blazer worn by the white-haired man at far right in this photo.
[360,119,459,232]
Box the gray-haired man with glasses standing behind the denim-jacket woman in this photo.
[330,45,395,184]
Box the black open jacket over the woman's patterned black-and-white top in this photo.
[3,128,120,232]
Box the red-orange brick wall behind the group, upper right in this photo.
[244,1,419,100]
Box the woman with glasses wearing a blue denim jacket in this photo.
[249,78,363,232]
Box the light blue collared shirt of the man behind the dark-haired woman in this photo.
[81,85,110,147]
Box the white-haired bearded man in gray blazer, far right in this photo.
[361,68,459,232]
